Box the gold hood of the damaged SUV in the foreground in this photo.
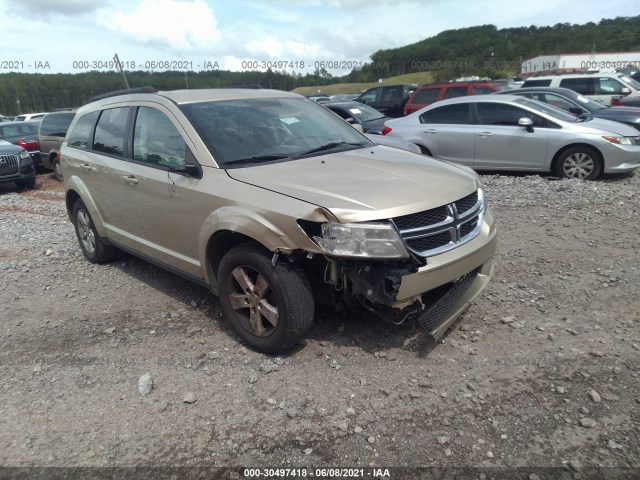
[227,145,480,222]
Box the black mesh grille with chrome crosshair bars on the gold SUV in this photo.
[391,189,484,257]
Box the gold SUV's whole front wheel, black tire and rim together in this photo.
[218,243,314,353]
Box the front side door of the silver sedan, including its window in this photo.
[473,102,549,170]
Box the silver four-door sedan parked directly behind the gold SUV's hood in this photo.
[382,95,640,180]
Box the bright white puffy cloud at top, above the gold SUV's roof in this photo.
[98,0,221,53]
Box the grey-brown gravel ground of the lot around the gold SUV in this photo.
[0,173,640,479]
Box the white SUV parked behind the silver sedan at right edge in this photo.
[522,73,640,106]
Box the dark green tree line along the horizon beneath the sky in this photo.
[0,15,640,115]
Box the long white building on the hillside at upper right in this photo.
[520,52,640,77]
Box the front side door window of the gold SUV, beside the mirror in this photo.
[133,107,187,168]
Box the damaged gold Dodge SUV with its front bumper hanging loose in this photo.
[61,89,496,352]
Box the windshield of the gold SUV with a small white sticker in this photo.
[181,98,372,167]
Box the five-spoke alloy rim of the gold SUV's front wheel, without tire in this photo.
[229,266,280,337]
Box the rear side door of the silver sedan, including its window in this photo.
[420,103,475,166]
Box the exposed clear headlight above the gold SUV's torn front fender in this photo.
[313,223,409,258]
